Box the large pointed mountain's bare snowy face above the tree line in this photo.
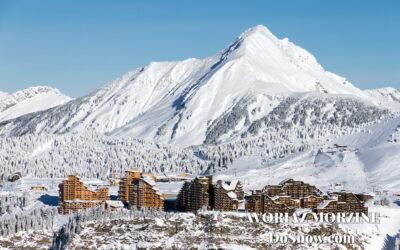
[0,25,382,146]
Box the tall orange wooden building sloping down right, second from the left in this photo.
[118,170,164,209]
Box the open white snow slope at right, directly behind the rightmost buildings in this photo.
[212,114,400,193]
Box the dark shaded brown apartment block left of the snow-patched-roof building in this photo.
[177,176,213,211]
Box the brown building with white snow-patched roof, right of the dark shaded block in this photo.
[211,180,244,211]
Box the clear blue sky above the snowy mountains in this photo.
[0,0,400,97]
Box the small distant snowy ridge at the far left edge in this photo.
[0,86,71,121]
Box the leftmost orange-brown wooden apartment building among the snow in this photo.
[59,175,109,214]
